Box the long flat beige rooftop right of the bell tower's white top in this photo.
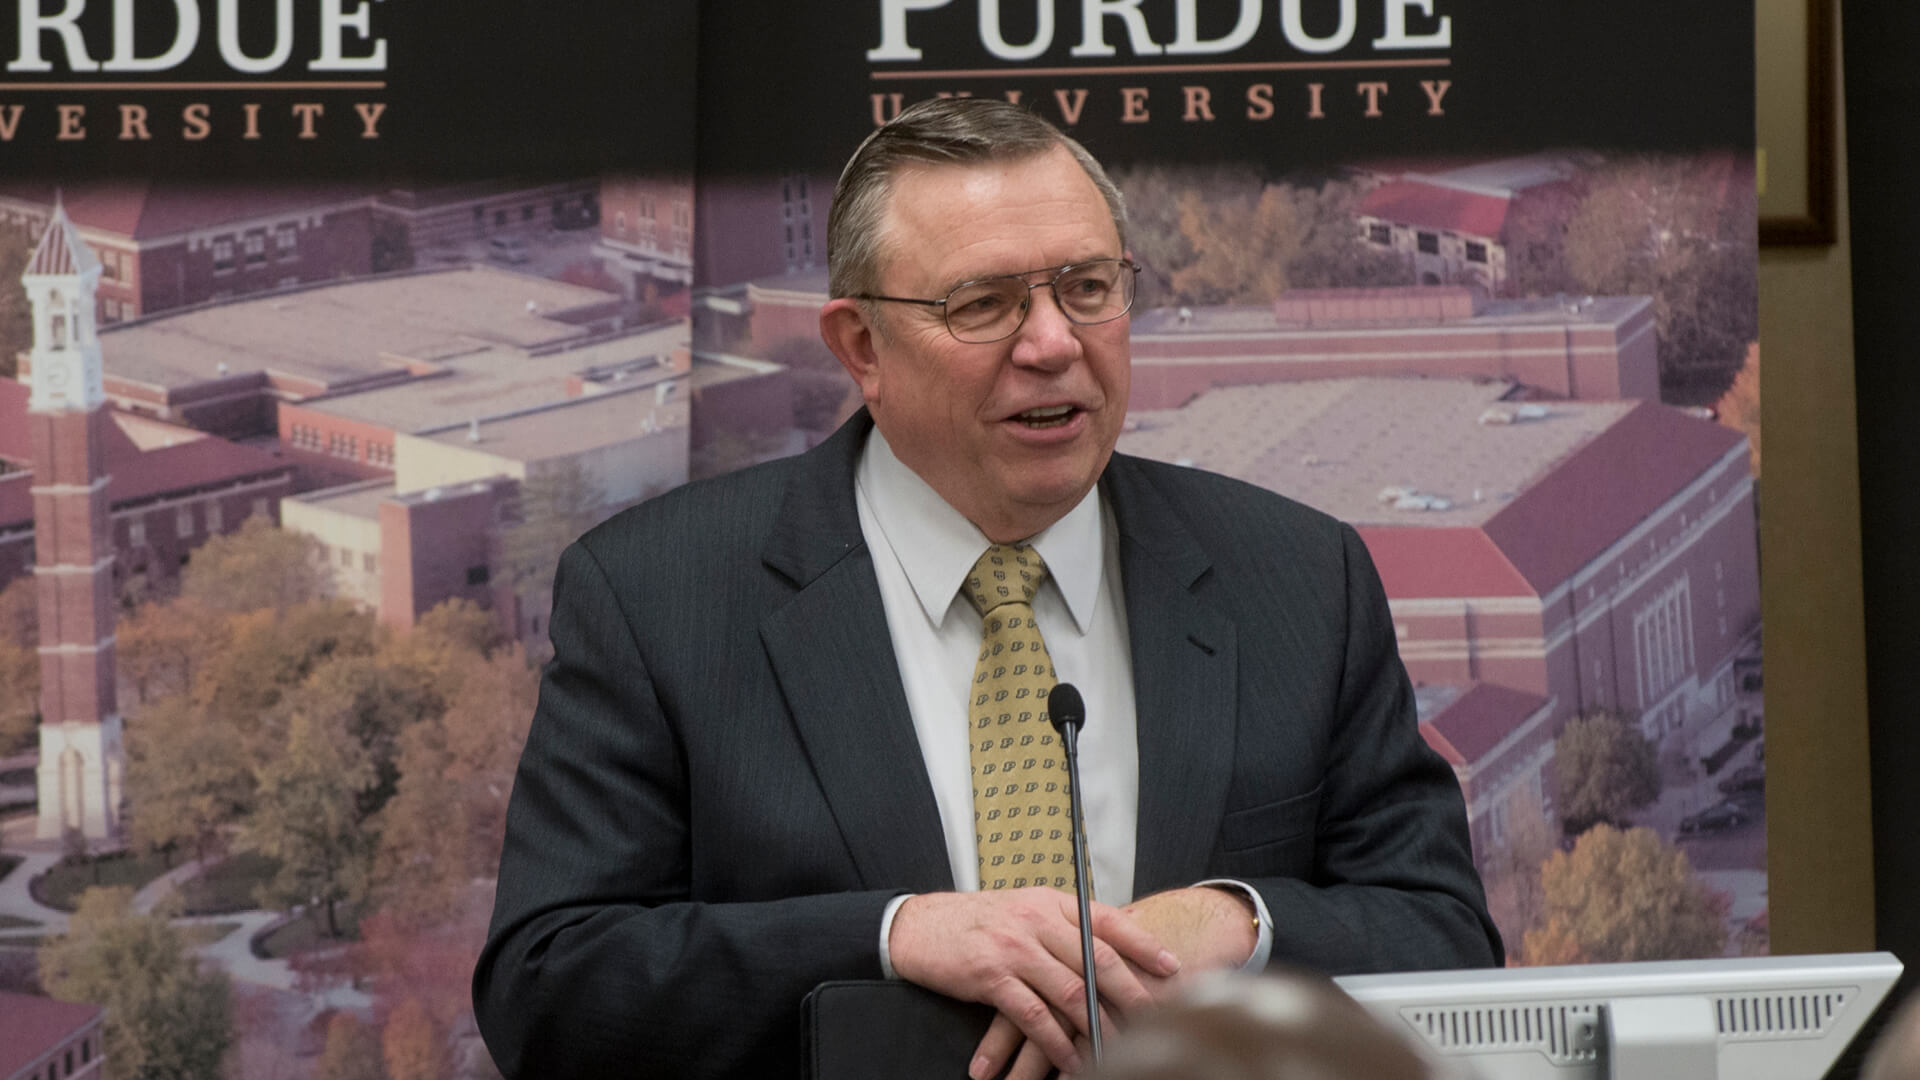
[100,265,618,388]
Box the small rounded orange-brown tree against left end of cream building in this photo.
[180,515,332,613]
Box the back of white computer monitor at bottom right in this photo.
[1334,953,1901,1080]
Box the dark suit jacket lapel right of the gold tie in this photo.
[1104,455,1238,896]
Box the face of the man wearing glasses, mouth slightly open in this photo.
[854,148,1131,542]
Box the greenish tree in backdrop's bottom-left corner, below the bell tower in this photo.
[38,888,232,1080]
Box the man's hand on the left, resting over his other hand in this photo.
[887,886,1181,1076]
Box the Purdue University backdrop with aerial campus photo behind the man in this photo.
[0,0,1766,1076]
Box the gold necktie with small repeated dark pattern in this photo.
[966,544,1073,892]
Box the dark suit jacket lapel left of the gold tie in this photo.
[760,411,952,892]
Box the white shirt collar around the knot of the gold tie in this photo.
[854,427,1106,634]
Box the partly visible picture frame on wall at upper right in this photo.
[1755,0,1836,246]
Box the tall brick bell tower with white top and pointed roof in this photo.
[21,202,127,840]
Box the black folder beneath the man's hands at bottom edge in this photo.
[801,980,993,1080]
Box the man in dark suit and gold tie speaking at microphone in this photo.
[474,100,1500,1076]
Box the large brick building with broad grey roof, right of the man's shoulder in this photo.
[1119,379,1761,828]
